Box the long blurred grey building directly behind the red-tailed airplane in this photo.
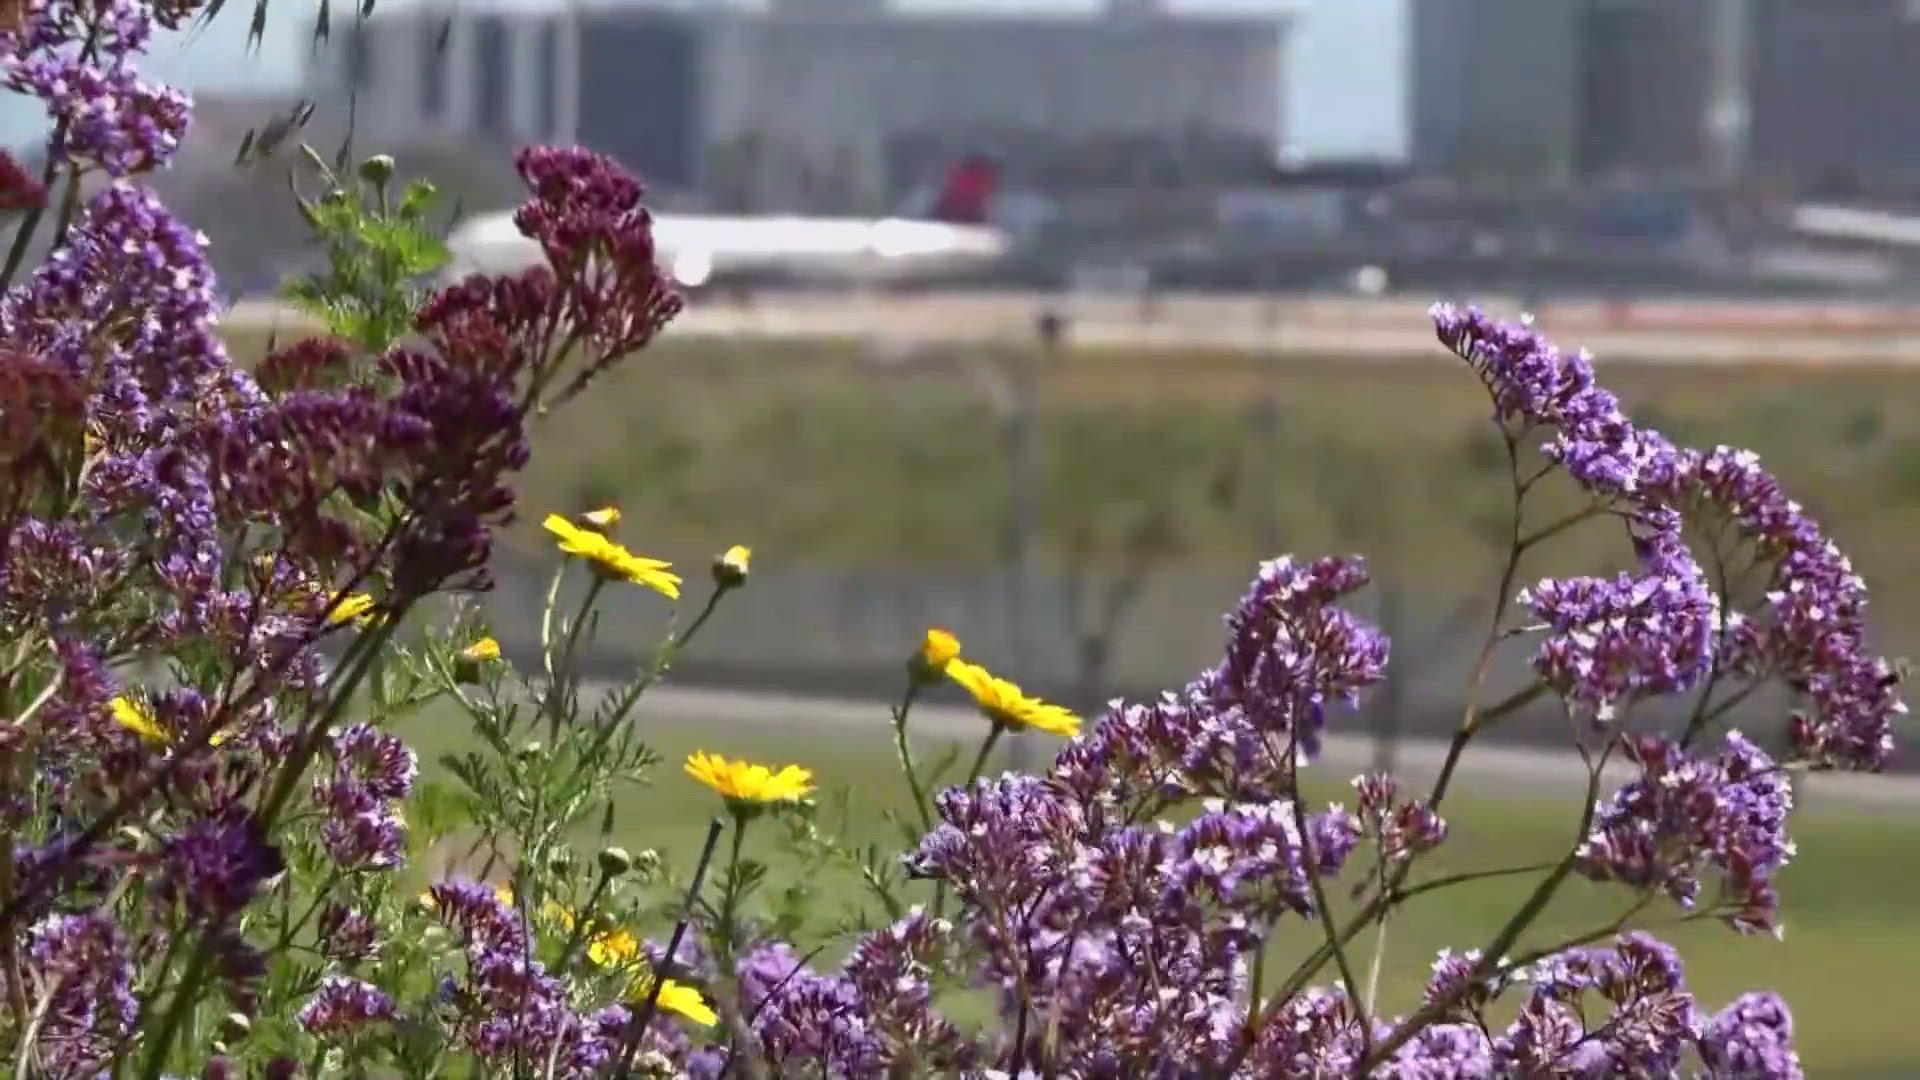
[324,0,1286,213]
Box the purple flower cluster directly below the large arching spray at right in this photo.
[1576,732,1793,930]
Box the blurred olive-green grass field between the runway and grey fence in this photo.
[224,322,1920,650]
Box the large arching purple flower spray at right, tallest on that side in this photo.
[1432,297,1907,771]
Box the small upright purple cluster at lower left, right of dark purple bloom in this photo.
[313,724,419,869]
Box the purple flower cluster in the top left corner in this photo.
[0,0,190,177]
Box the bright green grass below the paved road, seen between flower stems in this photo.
[403,705,1920,1076]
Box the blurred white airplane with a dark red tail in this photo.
[447,156,1012,290]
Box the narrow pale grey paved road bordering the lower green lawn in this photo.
[639,686,1920,807]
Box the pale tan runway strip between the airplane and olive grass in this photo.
[227,292,1920,369]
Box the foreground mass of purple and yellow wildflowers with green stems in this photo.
[0,0,1903,1080]
